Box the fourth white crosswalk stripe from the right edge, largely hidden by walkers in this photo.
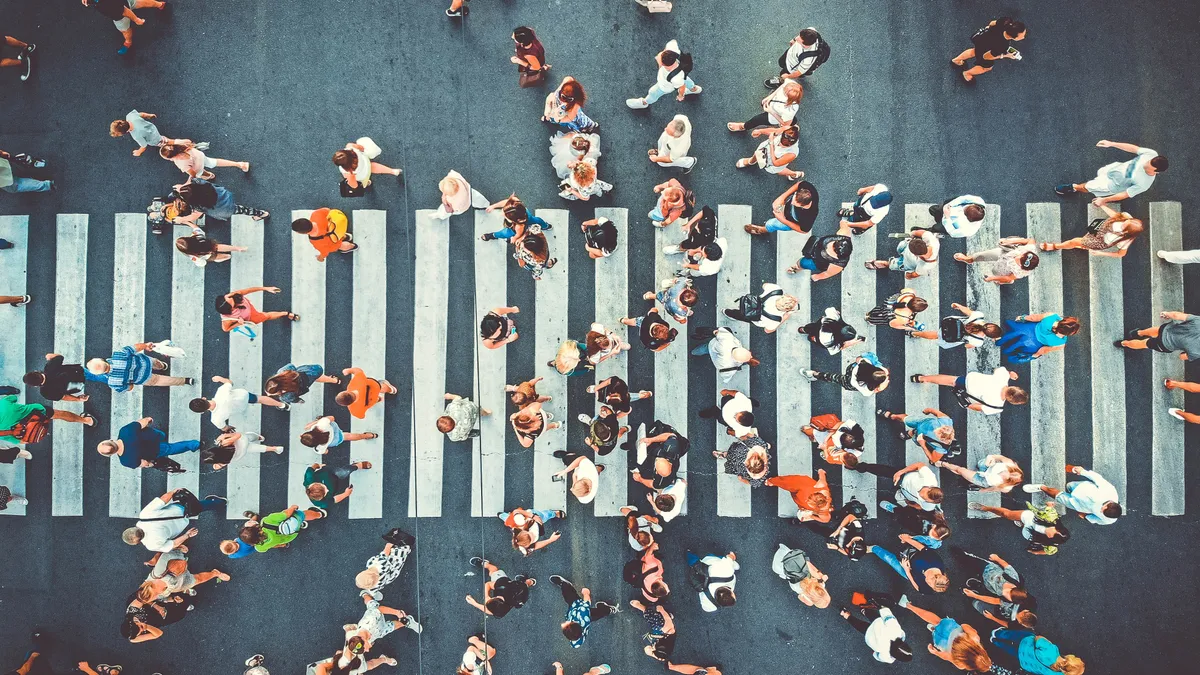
[966,204,1003,518]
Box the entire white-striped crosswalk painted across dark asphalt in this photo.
[0,202,1184,519]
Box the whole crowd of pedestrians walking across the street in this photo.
[0,0,1200,675]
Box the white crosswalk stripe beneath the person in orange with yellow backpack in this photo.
[289,210,328,508]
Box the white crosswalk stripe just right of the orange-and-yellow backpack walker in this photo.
[348,210,388,518]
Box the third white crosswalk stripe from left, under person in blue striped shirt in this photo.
[109,214,149,518]
